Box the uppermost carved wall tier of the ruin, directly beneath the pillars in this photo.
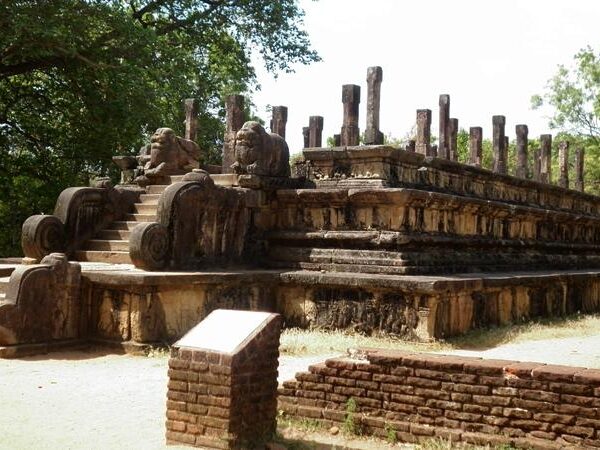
[303,146,600,215]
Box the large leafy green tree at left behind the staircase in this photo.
[0,0,319,256]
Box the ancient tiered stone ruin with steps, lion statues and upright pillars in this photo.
[0,67,600,356]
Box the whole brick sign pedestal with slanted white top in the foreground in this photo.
[166,309,282,449]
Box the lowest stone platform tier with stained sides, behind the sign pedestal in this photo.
[63,263,600,345]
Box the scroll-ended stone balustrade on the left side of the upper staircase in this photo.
[21,178,141,261]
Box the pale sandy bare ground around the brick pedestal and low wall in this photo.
[0,335,600,450]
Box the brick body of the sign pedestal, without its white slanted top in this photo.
[166,314,281,449]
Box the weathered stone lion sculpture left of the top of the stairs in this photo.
[136,128,200,184]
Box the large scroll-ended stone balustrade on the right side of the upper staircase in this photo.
[129,170,250,270]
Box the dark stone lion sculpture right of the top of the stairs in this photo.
[231,121,290,177]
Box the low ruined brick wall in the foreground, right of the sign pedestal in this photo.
[279,350,600,449]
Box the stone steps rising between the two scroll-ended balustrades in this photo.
[75,174,236,264]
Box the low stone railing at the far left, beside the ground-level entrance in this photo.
[0,253,81,346]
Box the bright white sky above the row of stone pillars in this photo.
[254,0,600,153]
